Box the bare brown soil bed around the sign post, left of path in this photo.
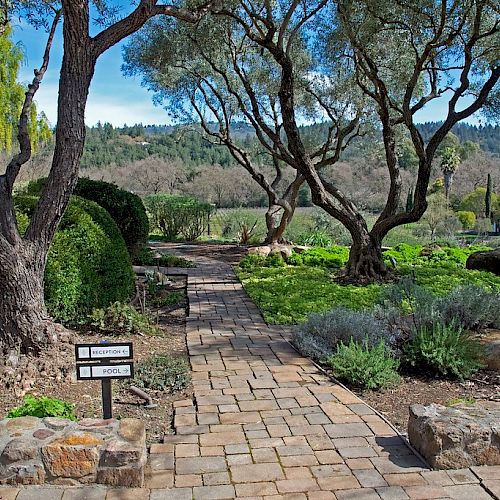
[0,276,191,443]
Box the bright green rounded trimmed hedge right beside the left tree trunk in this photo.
[15,196,134,323]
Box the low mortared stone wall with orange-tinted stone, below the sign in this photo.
[0,417,147,487]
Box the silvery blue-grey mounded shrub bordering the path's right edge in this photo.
[293,307,393,361]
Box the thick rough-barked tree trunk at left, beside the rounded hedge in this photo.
[0,2,97,354]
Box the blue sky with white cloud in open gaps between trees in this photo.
[13,15,479,126]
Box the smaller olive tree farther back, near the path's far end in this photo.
[125,2,366,243]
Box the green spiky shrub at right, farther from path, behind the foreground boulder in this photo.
[404,322,484,380]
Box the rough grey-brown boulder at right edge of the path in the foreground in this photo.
[408,401,500,469]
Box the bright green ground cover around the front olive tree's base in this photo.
[236,266,500,325]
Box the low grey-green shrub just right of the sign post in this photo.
[134,355,190,393]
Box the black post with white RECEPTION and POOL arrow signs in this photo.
[75,342,134,419]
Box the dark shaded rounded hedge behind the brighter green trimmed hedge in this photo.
[25,177,149,258]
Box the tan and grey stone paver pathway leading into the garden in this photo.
[0,247,500,500]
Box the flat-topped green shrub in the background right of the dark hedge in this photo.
[144,194,214,241]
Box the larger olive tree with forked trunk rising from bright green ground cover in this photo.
[203,0,500,282]
